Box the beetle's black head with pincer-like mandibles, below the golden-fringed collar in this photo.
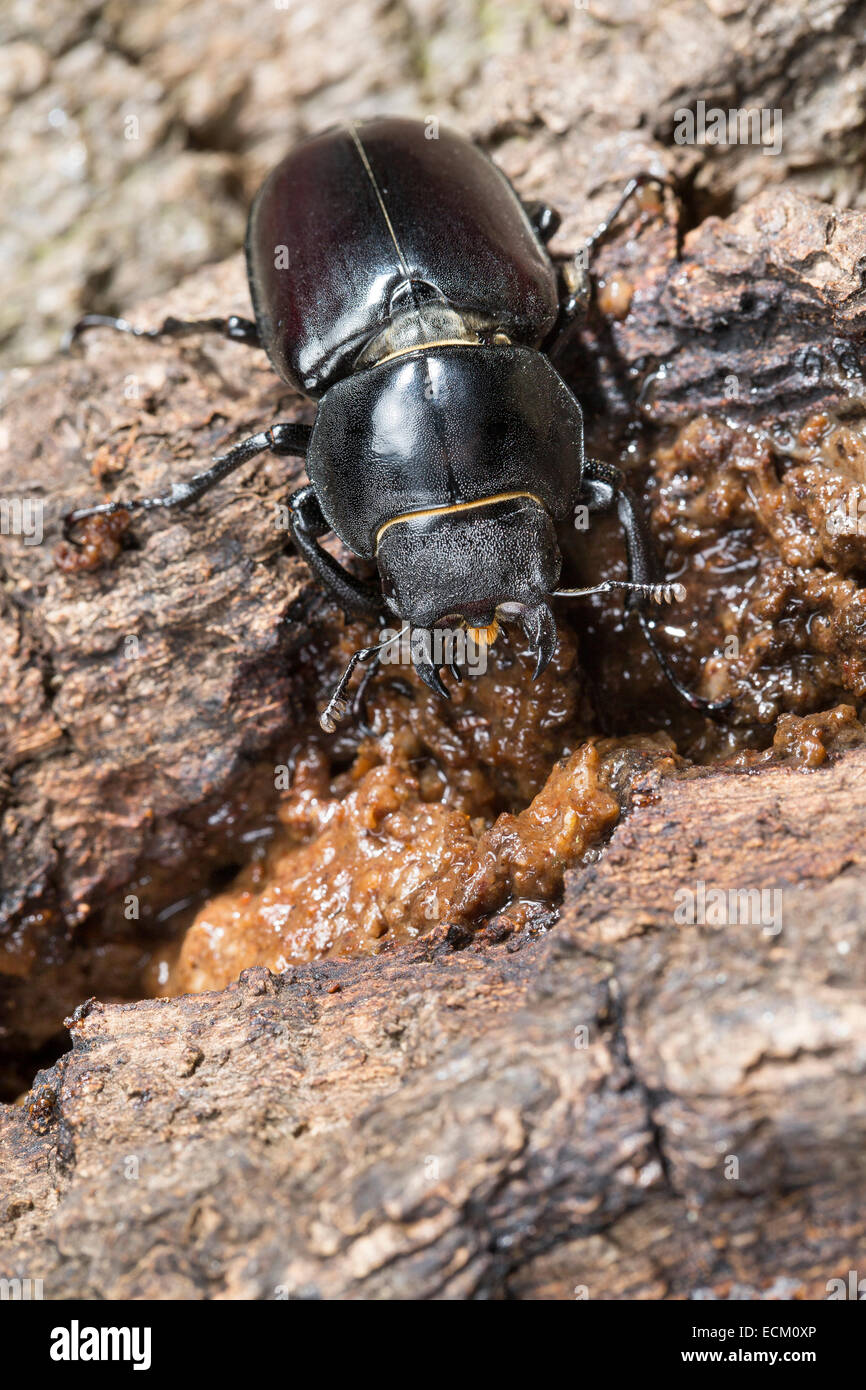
[377,493,562,695]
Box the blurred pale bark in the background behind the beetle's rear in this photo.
[0,0,866,366]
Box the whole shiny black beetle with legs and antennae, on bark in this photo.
[65,117,726,731]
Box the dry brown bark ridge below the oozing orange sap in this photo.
[0,751,866,1298]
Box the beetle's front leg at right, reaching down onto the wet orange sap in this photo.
[575,459,731,717]
